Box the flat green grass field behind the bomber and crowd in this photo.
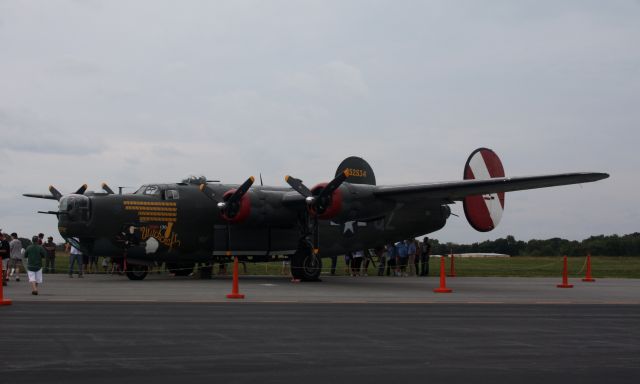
[27,253,640,279]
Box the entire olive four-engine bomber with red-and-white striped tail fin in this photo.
[24,148,609,281]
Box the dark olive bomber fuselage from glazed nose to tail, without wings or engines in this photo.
[58,183,449,265]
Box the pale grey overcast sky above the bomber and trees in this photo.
[0,0,640,243]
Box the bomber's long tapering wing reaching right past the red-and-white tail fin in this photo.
[373,172,609,201]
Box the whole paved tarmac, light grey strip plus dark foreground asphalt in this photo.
[0,275,640,383]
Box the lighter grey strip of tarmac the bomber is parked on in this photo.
[5,274,640,305]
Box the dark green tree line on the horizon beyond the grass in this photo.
[429,232,640,256]
